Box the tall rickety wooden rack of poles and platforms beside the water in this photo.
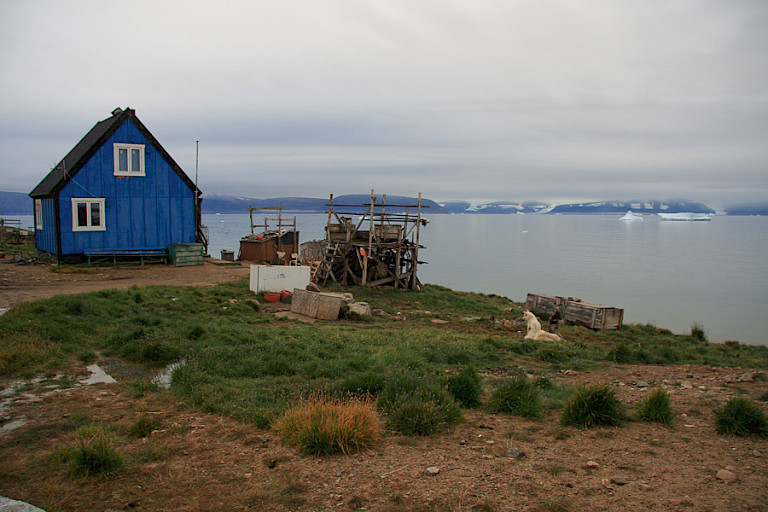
[312,190,427,290]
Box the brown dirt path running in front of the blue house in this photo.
[0,259,249,308]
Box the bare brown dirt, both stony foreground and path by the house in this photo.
[0,264,768,512]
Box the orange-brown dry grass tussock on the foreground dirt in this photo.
[273,396,381,455]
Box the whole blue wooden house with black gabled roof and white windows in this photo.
[29,108,204,261]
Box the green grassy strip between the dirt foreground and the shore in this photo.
[0,280,768,427]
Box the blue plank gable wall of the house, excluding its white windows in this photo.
[59,120,195,254]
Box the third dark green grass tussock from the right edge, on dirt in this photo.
[560,384,626,428]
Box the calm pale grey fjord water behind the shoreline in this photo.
[203,214,768,345]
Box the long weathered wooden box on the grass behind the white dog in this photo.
[525,293,624,330]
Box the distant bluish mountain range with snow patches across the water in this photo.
[0,191,768,216]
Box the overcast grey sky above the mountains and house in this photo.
[0,0,768,207]
